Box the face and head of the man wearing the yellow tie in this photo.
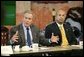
[56,10,66,24]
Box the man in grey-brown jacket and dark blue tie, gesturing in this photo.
[8,11,40,47]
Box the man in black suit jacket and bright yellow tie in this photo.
[45,9,77,46]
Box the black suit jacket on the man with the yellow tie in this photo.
[45,22,77,46]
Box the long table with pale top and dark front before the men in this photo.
[1,45,83,56]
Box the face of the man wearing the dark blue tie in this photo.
[23,13,33,27]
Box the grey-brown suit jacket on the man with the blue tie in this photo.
[8,24,40,47]
